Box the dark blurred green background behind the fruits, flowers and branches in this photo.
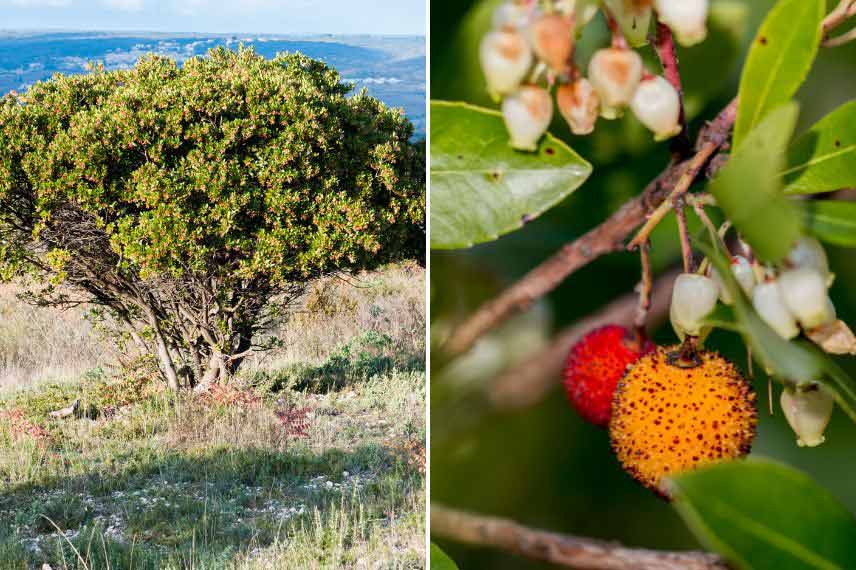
[430,0,856,570]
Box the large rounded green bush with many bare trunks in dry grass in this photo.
[0,48,425,389]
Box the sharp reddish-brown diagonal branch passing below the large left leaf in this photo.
[443,99,736,356]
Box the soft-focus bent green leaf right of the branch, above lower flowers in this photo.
[710,103,801,262]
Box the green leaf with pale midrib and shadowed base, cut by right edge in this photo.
[784,101,856,194]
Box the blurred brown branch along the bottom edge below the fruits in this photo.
[431,503,728,570]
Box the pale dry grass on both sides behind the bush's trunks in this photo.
[0,263,425,389]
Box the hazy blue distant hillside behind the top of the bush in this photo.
[0,32,426,137]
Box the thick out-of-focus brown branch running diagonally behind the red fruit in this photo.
[489,270,678,410]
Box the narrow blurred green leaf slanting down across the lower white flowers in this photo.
[697,237,856,421]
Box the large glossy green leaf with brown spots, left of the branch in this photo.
[431,101,592,249]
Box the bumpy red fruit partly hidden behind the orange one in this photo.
[564,325,655,427]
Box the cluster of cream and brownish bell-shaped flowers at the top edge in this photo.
[479,0,708,150]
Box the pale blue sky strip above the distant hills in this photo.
[0,0,426,35]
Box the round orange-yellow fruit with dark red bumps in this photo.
[609,346,758,498]
